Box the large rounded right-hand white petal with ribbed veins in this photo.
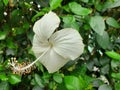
[50,28,84,60]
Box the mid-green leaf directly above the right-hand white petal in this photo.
[62,15,79,31]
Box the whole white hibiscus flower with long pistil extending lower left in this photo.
[8,11,84,73]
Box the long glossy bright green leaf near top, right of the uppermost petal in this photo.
[69,2,92,16]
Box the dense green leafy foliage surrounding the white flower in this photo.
[0,0,120,90]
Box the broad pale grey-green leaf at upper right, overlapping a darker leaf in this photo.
[89,16,105,35]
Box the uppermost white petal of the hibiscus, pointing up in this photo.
[33,11,60,41]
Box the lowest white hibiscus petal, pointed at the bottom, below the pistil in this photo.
[40,48,69,73]
